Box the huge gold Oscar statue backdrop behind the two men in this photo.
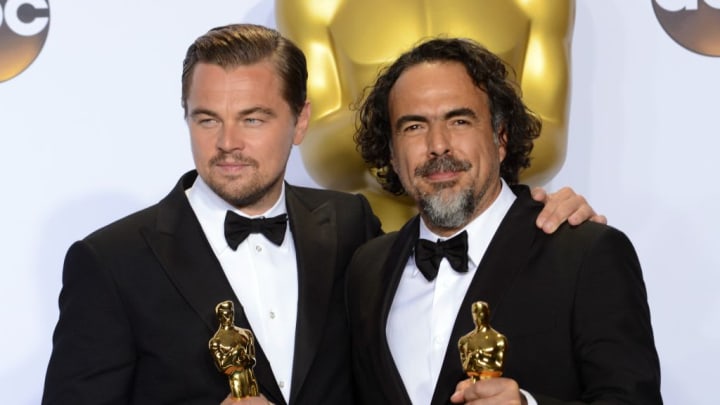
[276,0,574,231]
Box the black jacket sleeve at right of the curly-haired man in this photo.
[533,227,662,405]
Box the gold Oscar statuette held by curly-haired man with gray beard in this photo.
[458,301,507,382]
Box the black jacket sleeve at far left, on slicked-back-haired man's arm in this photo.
[42,241,136,405]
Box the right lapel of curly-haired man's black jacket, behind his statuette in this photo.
[431,186,542,405]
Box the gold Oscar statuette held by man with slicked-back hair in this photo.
[208,301,260,398]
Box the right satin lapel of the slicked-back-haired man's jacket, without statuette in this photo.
[286,185,344,403]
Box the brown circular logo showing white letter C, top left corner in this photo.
[0,0,50,82]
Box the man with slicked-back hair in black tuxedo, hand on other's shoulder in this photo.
[43,25,608,405]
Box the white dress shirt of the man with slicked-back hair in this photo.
[186,176,298,402]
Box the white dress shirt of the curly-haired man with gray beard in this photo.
[385,181,528,405]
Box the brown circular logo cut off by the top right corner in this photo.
[653,0,720,56]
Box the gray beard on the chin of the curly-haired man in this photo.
[420,188,477,229]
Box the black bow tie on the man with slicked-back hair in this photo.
[225,211,287,250]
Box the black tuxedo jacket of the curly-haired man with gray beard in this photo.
[347,186,662,405]
